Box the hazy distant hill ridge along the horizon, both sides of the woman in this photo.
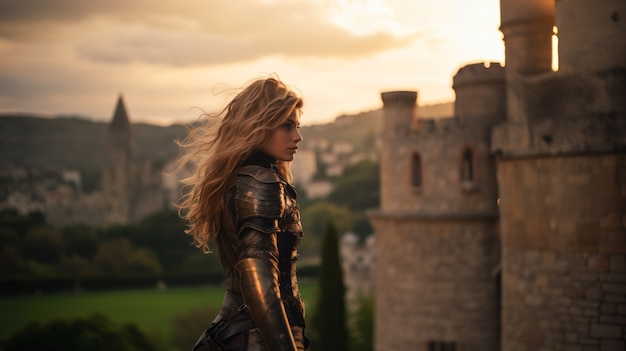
[0,102,452,171]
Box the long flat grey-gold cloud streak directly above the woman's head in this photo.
[76,20,412,66]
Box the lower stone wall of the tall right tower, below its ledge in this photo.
[498,154,626,351]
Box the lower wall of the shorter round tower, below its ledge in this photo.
[370,213,499,351]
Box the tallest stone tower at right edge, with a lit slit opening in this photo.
[492,0,626,351]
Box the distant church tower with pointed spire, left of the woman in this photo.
[103,95,164,225]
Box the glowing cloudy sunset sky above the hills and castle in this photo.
[0,0,504,125]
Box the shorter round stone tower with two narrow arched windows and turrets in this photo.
[369,64,506,351]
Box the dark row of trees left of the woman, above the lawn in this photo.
[0,209,221,286]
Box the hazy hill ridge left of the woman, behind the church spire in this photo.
[0,115,186,169]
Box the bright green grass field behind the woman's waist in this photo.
[0,283,316,348]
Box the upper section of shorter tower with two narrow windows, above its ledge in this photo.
[381,92,497,215]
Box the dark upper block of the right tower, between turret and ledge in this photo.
[492,69,626,158]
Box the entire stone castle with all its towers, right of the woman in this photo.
[369,0,626,351]
